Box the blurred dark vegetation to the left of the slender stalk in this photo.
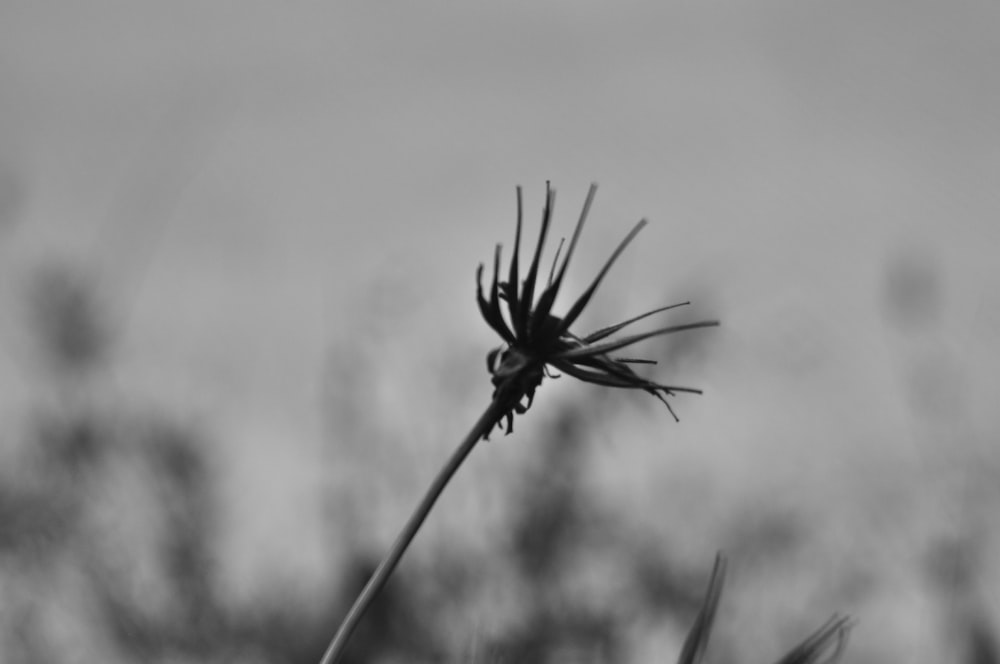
[0,266,317,663]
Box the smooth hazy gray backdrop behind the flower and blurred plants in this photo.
[0,0,1000,663]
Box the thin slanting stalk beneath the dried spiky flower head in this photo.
[320,399,510,664]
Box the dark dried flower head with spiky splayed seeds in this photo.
[476,184,718,433]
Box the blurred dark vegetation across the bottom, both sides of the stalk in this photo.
[0,255,1000,664]
